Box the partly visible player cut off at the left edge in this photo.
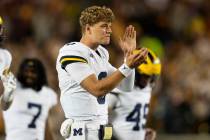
[0,16,16,110]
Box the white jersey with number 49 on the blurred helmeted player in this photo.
[107,86,152,140]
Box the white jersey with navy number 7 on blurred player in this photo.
[3,85,57,140]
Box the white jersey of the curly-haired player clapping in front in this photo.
[56,42,116,124]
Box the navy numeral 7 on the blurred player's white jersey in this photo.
[28,103,42,128]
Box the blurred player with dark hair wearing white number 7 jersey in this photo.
[3,58,57,140]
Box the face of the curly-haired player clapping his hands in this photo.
[90,22,112,45]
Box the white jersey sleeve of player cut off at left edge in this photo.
[0,48,12,77]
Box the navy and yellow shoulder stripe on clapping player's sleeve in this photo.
[60,55,88,69]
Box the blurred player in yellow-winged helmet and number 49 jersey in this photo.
[107,50,161,140]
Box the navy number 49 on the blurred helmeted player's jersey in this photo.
[126,103,149,131]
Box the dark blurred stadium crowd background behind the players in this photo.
[0,0,210,140]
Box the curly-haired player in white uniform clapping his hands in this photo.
[56,6,147,140]
